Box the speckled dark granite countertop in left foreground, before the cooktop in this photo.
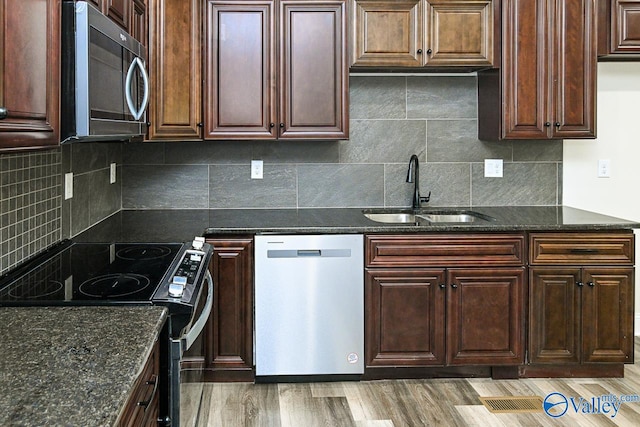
[0,306,166,426]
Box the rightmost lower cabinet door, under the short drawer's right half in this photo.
[582,267,634,363]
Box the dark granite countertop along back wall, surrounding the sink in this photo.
[74,206,640,242]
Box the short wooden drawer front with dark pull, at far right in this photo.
[529,231,634,265]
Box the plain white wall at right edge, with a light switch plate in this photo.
[563,62,640,335]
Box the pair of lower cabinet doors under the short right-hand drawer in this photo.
[529,266,634,364]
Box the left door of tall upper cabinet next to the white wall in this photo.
[501,0,552,139]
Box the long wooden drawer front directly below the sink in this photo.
[365,234,525,267]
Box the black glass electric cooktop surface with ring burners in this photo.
[0,243,182,305]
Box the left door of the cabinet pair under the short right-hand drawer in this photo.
[529,267,582,363]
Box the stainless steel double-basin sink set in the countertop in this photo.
[363,210,494,224]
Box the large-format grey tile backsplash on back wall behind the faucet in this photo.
[122,74,562,209]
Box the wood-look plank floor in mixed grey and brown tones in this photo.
[181,338,640,427]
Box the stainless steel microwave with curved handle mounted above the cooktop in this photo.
[60,1,149,142]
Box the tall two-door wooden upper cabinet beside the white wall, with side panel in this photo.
[478,0,597,140]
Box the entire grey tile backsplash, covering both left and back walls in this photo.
[0,74,562,274]
